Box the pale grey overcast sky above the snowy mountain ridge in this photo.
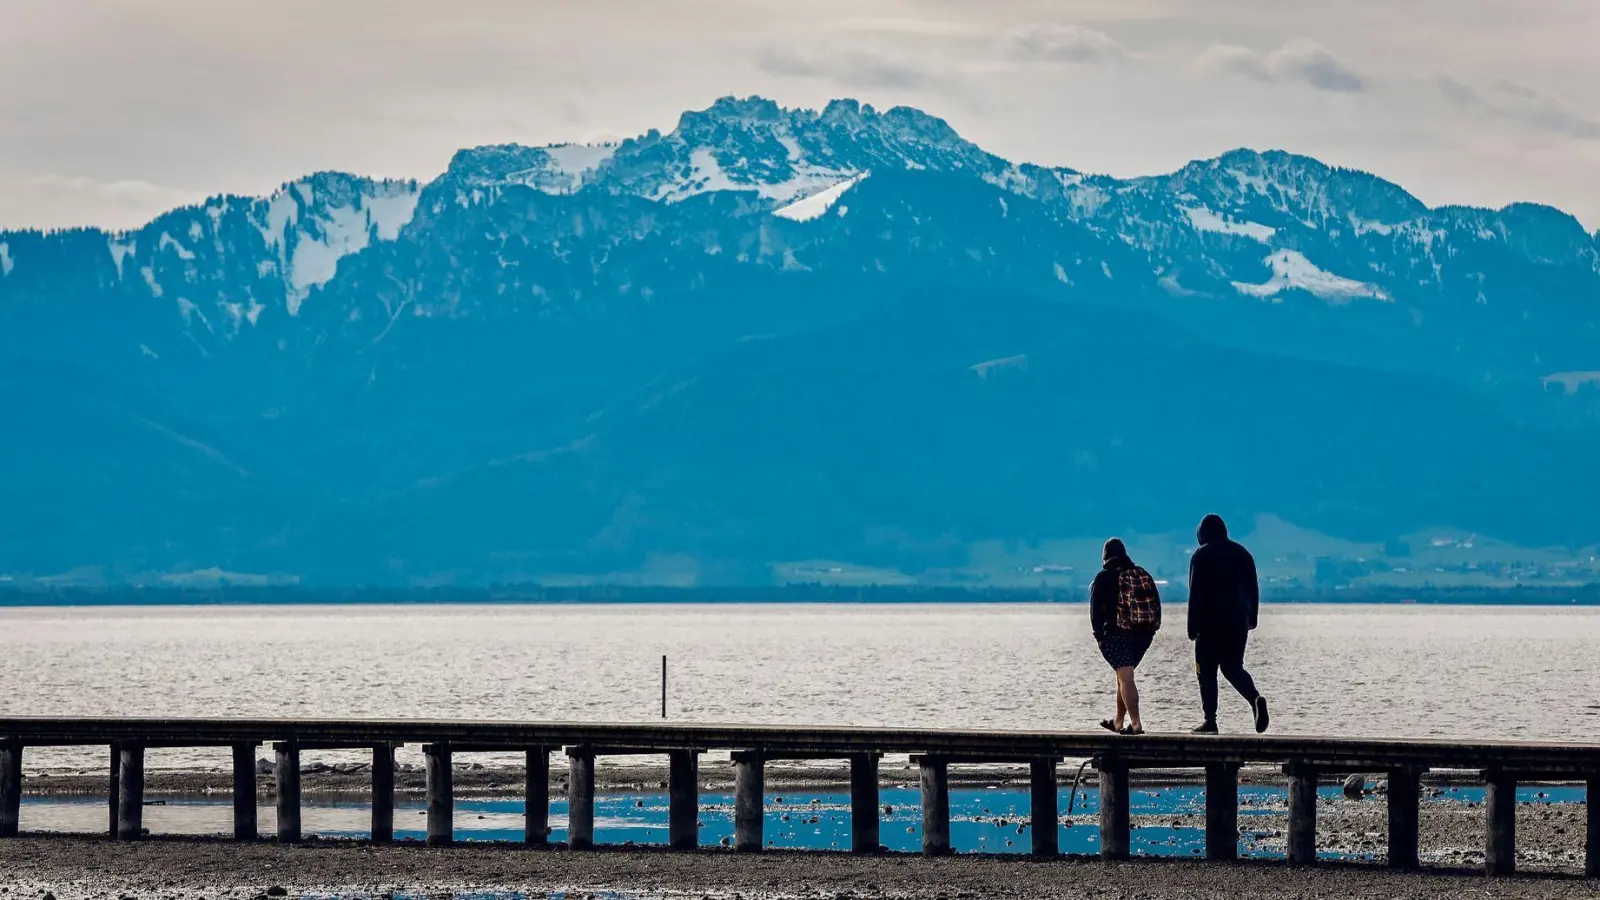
[0,0,1600,229]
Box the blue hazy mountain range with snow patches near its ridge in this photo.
[0,98,1600,585]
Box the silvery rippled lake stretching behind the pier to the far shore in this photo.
[0,605,1600,770]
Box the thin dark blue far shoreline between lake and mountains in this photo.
[0,585,1600,609]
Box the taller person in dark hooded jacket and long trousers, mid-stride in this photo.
[1189,516,1267,735]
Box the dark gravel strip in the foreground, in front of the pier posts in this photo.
[0,838,1597,900]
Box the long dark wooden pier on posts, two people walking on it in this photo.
[0,717,1600,878]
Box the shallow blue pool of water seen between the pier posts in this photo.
[22,786,1584,857]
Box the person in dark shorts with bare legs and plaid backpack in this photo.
[1090,538,1162,735]
